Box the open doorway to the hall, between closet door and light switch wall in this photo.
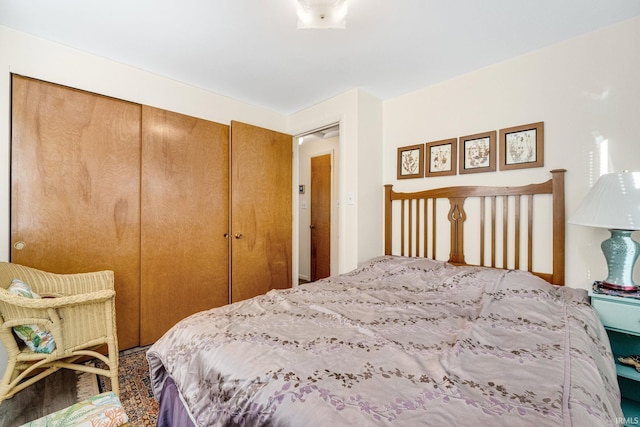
[296,124,340,283]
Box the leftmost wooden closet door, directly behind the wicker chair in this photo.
[11,75,140,348]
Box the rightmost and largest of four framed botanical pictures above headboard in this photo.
[500,122,544,170]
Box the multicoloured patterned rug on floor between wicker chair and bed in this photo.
[95,347,158,427]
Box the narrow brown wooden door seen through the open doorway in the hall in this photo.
[310,154,331,282]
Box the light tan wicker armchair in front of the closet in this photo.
[0,262,119,403]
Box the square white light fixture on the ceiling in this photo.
[297,0,347,29]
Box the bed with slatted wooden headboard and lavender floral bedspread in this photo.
[147,171,623,426]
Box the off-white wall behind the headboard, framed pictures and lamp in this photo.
[383,19,640,288]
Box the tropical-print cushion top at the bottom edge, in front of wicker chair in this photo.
[22,391,129,427]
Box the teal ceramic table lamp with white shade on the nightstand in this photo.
[569,171,640,291]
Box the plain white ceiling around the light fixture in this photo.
[0,0,640,114]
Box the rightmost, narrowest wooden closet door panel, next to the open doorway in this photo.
[231,122,293,302]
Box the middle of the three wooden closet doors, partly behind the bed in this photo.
[140,106,229,345]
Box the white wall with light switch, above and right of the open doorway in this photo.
[288,89,383,273]
